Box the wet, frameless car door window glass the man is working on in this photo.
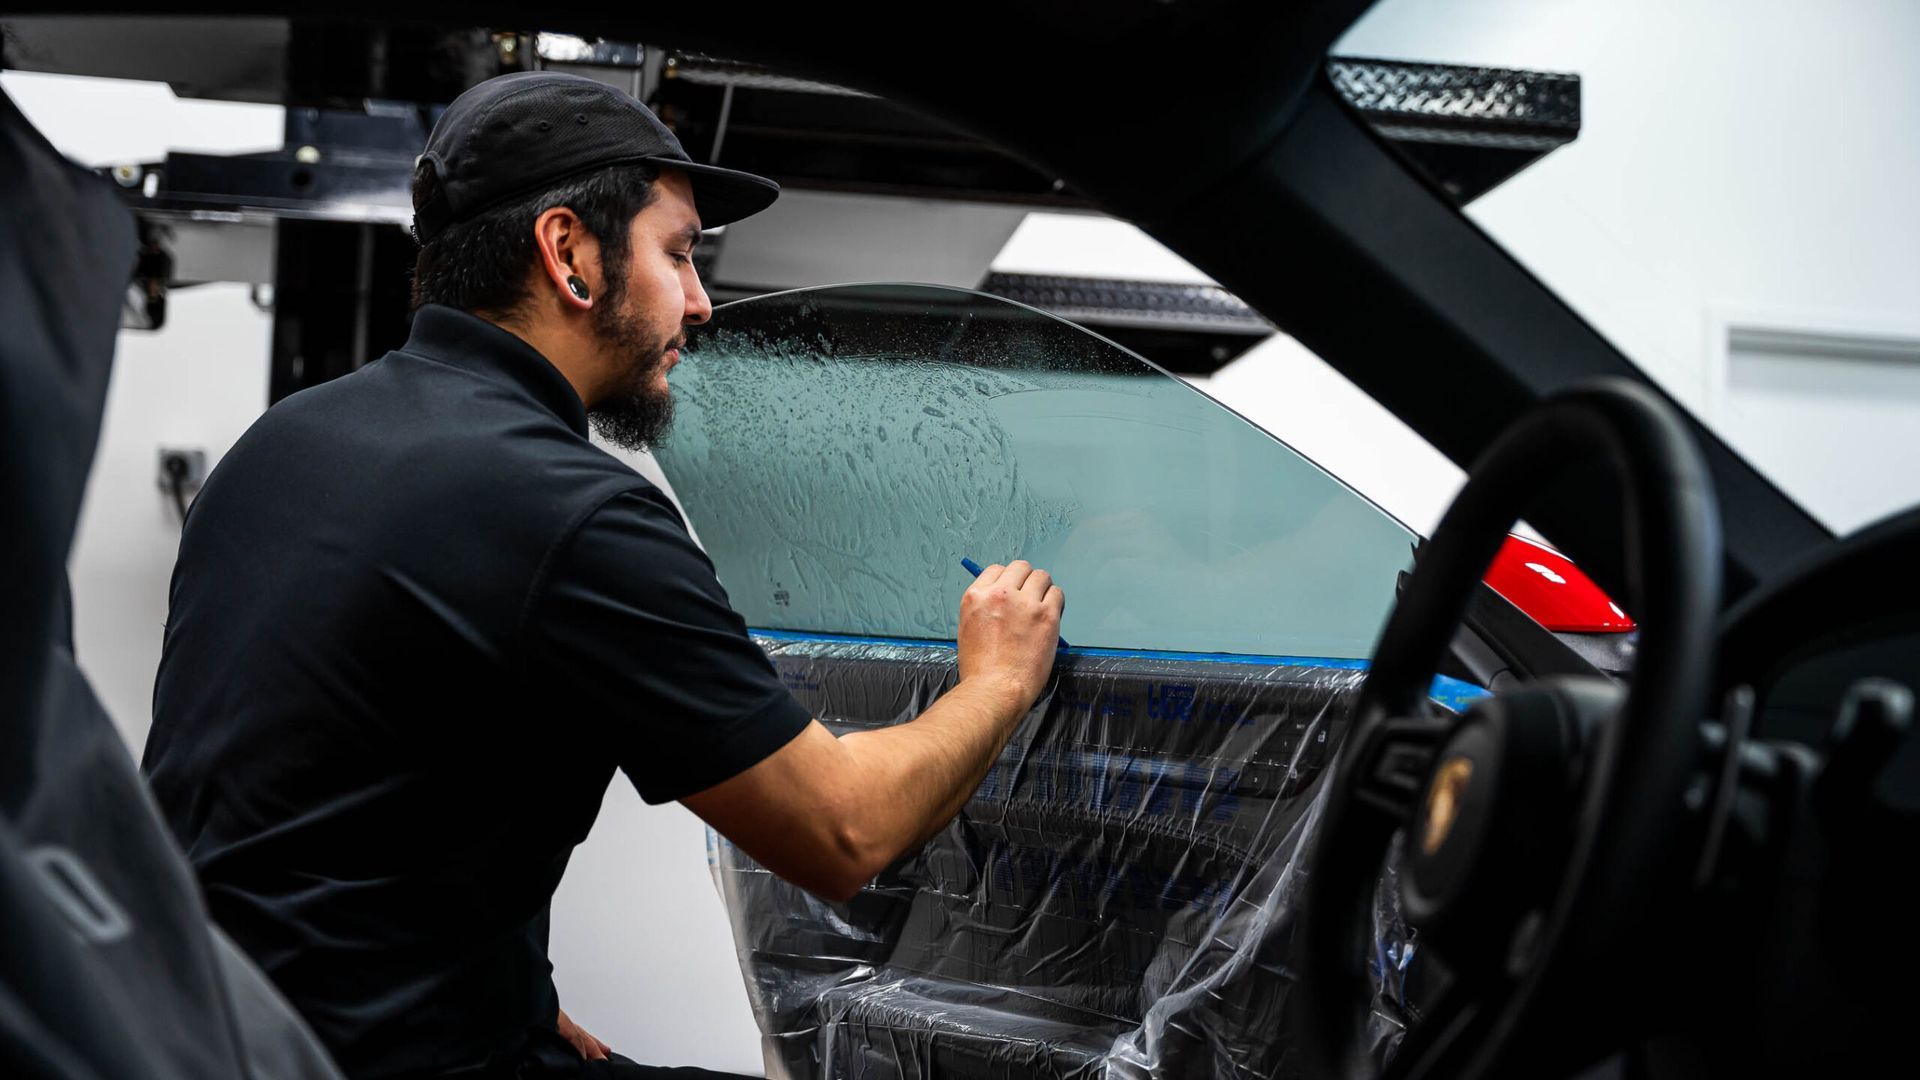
[659,284,1415,659]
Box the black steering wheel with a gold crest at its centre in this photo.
[1298,379,1720,1078]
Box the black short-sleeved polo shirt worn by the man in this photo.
[144,306,808,1076]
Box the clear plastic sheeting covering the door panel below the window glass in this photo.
[710,632,1413,1078]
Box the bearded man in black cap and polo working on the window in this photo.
[144,73,1064,1076]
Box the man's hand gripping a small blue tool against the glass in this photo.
[960,559,1068,711]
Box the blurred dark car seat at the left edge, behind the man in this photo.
[0,82,338,1080]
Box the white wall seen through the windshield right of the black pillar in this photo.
[1334,0,1920,532]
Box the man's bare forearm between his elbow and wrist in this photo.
[841,680,1027,865]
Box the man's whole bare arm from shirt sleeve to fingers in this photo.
[682,561,1066,899]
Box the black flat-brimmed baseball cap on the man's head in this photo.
[413,71,780,244]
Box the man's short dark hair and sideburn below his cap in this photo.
[413,161,660,317]
